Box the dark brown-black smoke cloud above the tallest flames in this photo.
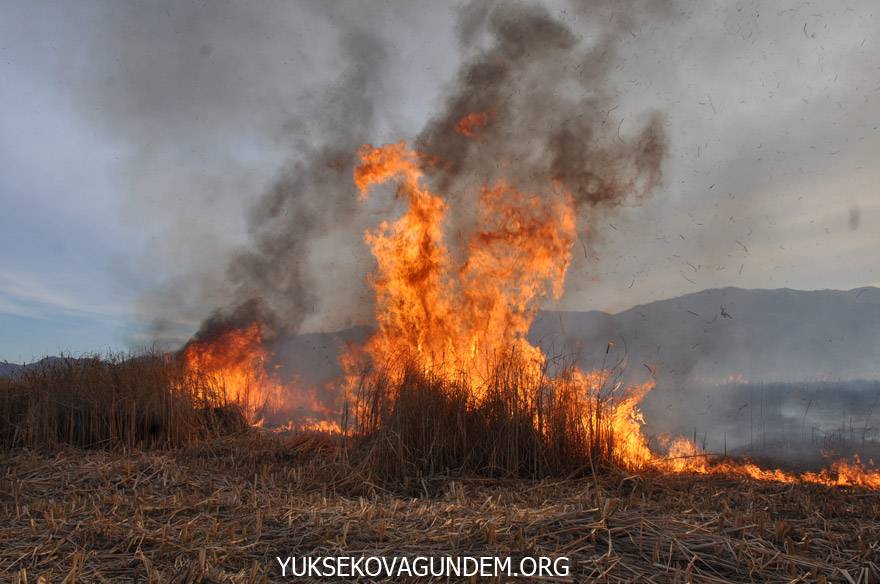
[417,3,666,216]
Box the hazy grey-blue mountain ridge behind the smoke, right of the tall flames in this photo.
[530,288,880,381]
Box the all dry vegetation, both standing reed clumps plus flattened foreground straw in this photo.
[0,356,880,584]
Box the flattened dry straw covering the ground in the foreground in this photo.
[0,437,880,583]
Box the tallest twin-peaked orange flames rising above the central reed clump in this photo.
[355,143,575,387]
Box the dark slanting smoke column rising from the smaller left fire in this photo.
[199,32,385,342]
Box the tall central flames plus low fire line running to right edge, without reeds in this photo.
[342,140,880,488]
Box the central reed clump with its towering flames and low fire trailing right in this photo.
[342,142,880,487]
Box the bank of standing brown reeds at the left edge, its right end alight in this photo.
[0,353,247,448]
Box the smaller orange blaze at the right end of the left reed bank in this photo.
[182,323,284,423]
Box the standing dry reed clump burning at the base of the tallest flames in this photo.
[343,353,648,482]
